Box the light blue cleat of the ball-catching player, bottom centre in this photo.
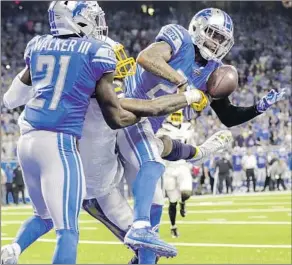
[124,227,177,257]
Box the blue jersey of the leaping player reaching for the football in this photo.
[125,24,221,132]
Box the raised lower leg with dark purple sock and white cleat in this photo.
[160,130,233,164]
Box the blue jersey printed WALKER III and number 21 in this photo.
[24,35,116,138]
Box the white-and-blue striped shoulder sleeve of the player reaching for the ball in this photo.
[155,24,184,57]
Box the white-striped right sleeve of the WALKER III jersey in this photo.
[91,43,117,80]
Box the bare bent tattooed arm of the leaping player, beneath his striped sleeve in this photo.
[137,41,187,86]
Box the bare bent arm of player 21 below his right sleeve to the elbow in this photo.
[95,72,140,129]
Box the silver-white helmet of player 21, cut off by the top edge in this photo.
[48,1,108,39]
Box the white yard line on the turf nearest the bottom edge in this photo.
[2,237,291,249]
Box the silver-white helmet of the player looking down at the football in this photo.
[189,8,234,61]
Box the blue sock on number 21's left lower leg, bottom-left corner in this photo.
[13,216,54,252]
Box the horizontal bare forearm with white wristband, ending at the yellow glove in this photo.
[120,89,202,117]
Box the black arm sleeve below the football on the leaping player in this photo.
[210,98,261,127]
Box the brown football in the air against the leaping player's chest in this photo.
[207,65,238,99]
